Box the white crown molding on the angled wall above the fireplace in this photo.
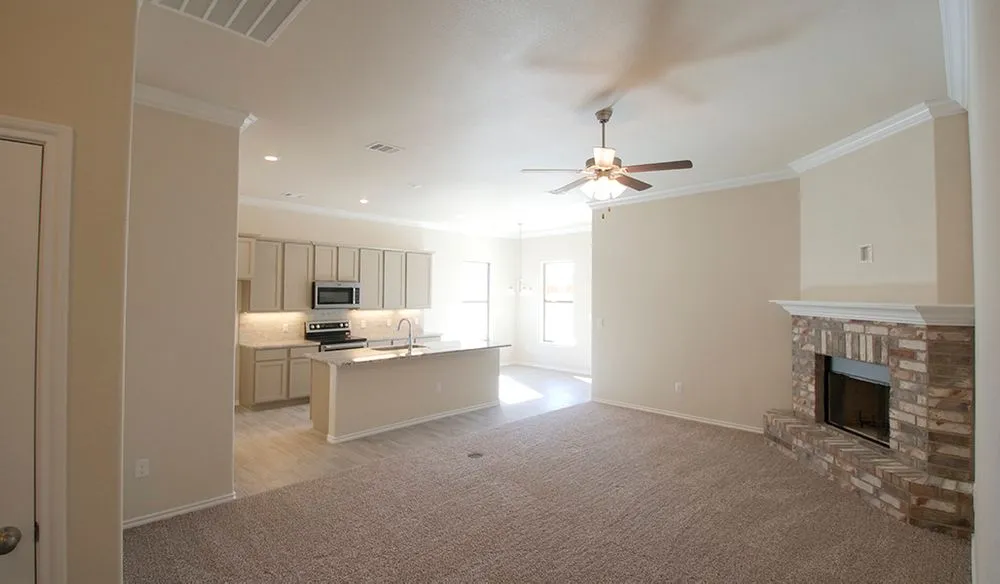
[788,99,965,174]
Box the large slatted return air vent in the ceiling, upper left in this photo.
[153,0,309,45]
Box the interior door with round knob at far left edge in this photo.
[0,138,42,584]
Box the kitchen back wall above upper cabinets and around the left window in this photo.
[239,205,517,363]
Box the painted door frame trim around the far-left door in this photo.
[0,115,73,584]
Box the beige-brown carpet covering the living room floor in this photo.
[125,404,971,584]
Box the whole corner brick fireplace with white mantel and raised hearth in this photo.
[764,301,974,538]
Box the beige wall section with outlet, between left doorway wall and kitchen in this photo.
[124,105,239,520]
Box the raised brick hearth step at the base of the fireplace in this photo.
[764,410,973,539]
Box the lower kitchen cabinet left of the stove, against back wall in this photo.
[239,346,317,408]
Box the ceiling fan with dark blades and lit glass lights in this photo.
[521,107,694,201]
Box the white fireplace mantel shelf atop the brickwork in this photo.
[771,300,975,326]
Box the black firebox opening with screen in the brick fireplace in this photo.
[824,357,889,446]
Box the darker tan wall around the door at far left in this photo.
[0,0,136,582]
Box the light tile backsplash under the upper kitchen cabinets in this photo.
[239,310,424,343]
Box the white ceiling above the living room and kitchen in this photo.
[137,0,947,237]
